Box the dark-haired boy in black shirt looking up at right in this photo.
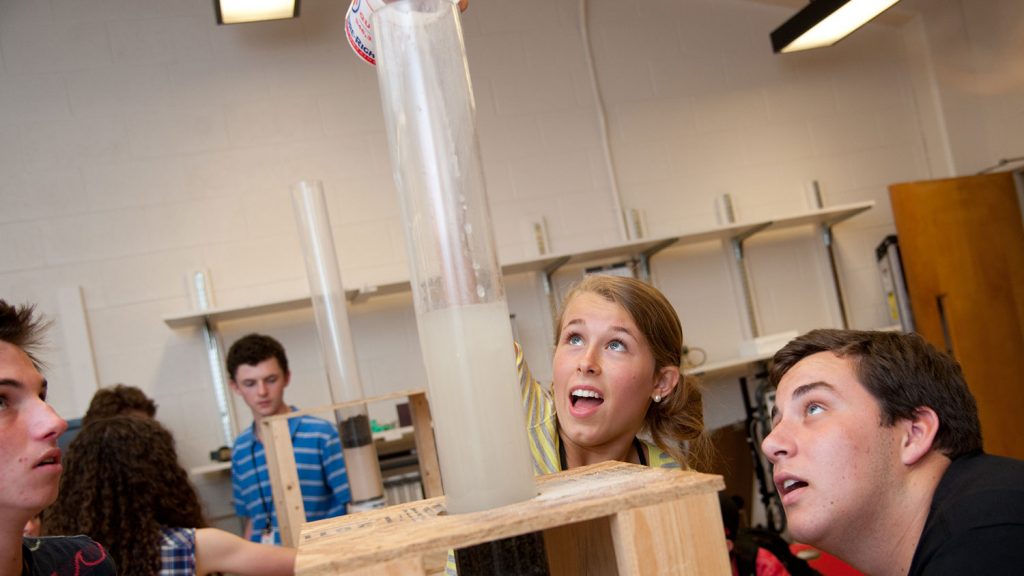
[762,330,1024,575]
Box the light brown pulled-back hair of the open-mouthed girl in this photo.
[555,275,714,469]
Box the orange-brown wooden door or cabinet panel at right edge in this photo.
[889,172,1024,458]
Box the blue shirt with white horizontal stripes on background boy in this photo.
[231,407,352,544]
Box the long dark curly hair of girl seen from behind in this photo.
[44,416,206,575]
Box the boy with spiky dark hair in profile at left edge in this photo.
[0,300,116,576]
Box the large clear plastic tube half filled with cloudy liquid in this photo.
[374,0,537,513]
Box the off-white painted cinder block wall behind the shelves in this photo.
[0,0,1024,528]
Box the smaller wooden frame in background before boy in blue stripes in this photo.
[261,390,443,546]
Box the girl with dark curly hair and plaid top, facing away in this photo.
[44,416,295,576]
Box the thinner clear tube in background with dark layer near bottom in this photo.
[292,180,384,507]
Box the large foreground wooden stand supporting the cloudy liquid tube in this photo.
[296,461,731,576]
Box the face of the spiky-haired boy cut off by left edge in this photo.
[0,341,68,520]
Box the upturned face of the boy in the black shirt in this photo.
[761,352,903,550]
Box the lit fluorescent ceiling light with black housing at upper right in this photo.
[771,0,899,52]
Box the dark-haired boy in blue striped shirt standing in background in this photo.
[226,334,351,544]
